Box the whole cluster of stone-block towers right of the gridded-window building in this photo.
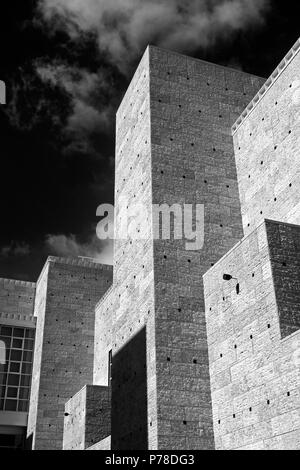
[0,41,300,450]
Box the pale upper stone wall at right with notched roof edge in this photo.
[233,40,300,234]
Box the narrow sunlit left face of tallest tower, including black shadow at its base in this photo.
[111,49,157,450]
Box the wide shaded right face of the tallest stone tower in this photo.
[150,48,264,449]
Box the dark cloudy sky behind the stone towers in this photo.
[0,0,299,281]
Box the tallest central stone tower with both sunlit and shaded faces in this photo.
[94,47,264,449]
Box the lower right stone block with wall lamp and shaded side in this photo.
[204,220,300,449]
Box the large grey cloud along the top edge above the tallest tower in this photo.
[39,0,269,72]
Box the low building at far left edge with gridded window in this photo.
[0,279,36,449]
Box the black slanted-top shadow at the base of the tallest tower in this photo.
[111,327,148,450]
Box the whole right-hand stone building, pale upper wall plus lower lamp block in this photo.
[204,40,300,449]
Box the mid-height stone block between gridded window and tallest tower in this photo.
[27,257,112,449]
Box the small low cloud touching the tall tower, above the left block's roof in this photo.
[46,234,113,264]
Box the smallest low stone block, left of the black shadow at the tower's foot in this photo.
[63,385,111,450]
